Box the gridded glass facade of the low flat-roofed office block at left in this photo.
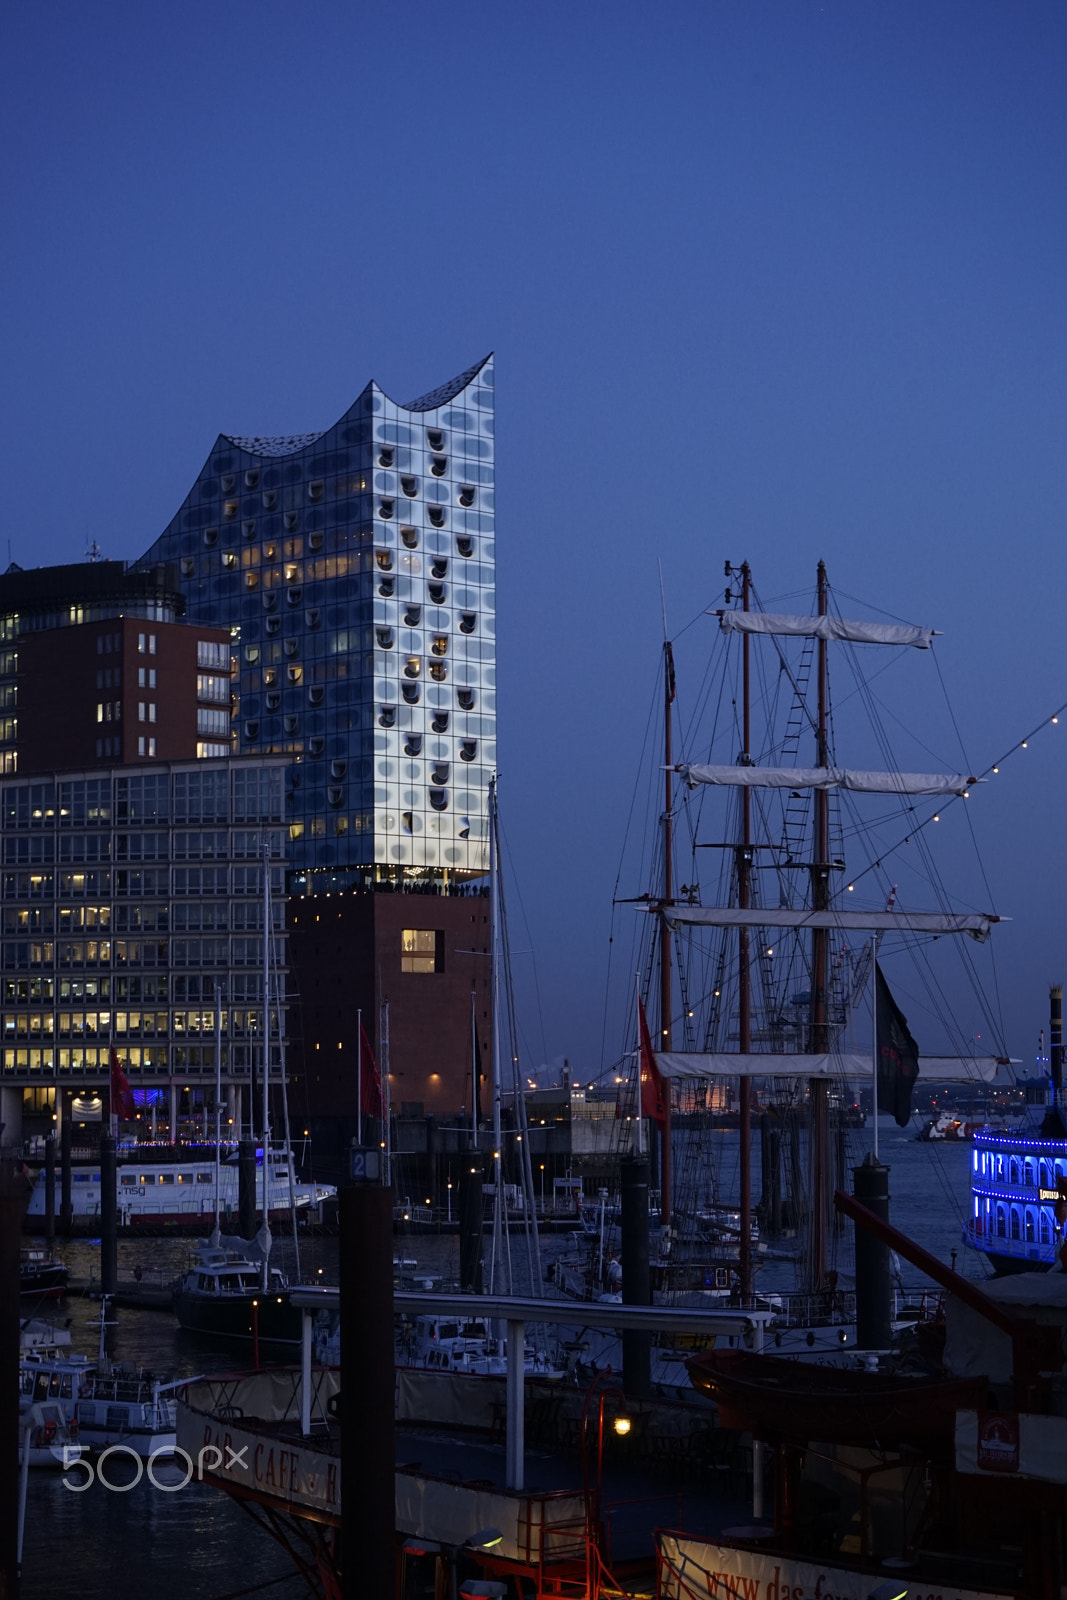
[0,758,286,1085]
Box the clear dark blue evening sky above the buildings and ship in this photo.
[0,0,1067,1070]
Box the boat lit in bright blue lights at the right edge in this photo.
[963,984,1067,1275]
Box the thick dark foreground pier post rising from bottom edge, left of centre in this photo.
[340,1184,397,1600]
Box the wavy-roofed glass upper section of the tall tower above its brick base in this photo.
[139,357,496,891]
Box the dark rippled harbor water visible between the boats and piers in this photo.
[22,1118,987,1600]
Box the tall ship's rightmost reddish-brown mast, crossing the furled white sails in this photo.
[808,562,830,1291]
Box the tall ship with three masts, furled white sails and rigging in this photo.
[607,563,1008,1318]
